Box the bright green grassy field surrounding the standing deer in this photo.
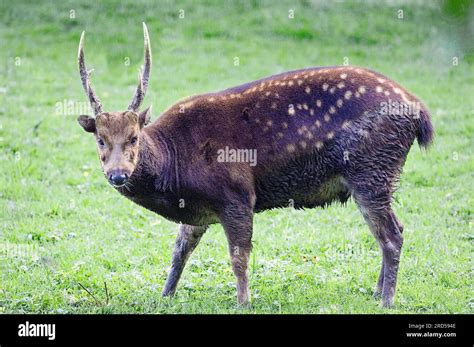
[0,0,474,313]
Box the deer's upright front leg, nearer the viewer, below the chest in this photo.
[221,207,253,305]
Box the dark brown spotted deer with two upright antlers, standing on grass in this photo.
[78,23,434,307]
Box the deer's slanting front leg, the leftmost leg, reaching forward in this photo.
[162,224,207,296]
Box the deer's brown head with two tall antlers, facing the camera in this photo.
[78,23,151,186]
